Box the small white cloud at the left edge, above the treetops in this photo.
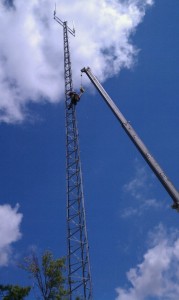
[0,204,22,266]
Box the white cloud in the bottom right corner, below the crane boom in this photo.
[116,225,179,300]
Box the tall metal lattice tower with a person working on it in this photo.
[54,11,92,300]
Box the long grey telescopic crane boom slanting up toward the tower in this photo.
[81,67,179,211]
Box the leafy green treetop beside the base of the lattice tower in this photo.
[20,251,68,300]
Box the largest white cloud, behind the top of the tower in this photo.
[0,0,153,122]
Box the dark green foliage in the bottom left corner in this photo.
[0,285,31,300]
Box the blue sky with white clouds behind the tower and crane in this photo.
[0,0,179,300]
